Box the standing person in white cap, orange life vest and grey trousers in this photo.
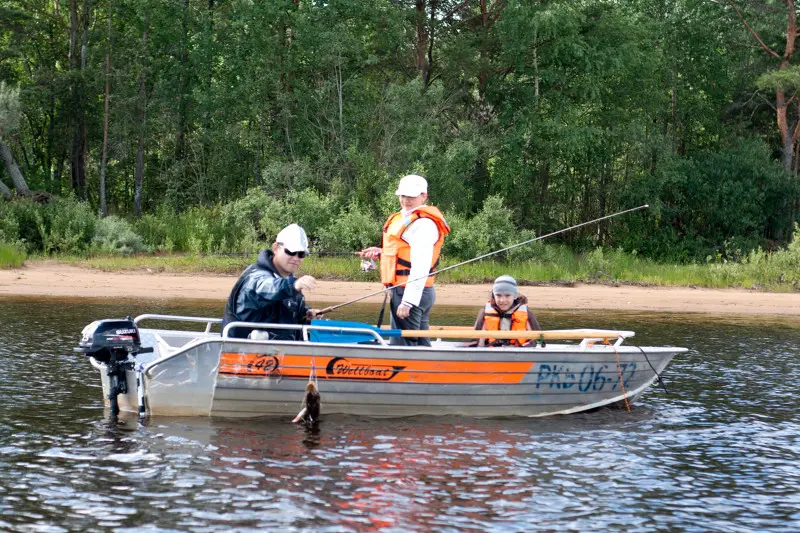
[359,174,450,346]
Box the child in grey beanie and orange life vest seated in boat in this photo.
[474,275,541,346]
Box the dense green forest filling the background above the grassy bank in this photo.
[0,0,800,261]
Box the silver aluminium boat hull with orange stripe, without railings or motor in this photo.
[97,330,686,417]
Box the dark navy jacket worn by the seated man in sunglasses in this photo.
[222,250,308,340]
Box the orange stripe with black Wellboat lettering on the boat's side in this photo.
[219,352,535,383]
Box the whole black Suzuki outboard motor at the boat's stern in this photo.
[75,317,153,415]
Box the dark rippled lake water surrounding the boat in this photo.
[0,298,800,533]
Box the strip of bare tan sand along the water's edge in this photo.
[0,260,800,317]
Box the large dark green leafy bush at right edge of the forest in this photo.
[615,139,798,262]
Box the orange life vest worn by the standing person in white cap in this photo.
[381,205,450,287]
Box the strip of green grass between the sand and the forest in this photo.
[47,245,800,292]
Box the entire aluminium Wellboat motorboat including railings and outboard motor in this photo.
[76,314,686,417]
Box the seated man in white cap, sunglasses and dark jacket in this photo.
[222,224,318,340]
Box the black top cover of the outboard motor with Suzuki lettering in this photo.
[75,317,142,364]
